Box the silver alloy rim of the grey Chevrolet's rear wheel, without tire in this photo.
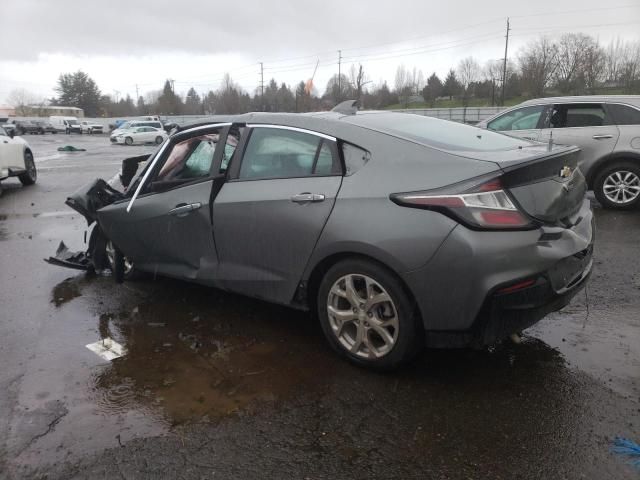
[327,274,399,359]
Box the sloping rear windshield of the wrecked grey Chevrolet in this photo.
[353,113,531,152]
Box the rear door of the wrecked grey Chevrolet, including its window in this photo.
[213,125,342,304]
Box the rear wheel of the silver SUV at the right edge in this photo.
[593,162,640,210]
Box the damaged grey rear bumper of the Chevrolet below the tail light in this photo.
[403,201,594,347]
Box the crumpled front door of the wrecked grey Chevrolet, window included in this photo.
[98,125,226,284]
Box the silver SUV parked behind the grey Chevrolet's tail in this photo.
[478,95,640,209]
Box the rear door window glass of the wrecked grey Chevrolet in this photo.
[240,128,335,179]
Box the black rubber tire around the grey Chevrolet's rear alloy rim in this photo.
[316,259,424,370]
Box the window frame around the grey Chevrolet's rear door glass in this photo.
[227,123,344,182]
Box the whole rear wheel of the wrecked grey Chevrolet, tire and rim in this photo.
[317,259,424,370]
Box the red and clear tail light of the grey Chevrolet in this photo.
[391,179,532,230]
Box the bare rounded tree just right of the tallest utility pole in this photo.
[518,37,558,97]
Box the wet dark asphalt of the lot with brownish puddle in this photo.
[0,135,640,480]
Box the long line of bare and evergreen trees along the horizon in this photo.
[9,33,640,117]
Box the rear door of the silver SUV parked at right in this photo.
[540,102,620,175]
